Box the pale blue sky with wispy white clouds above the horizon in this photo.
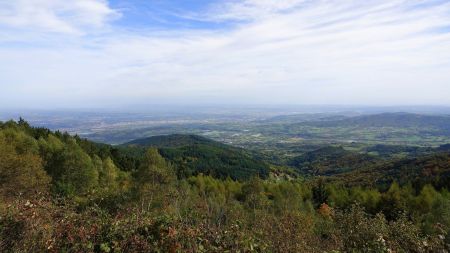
[0,0,450,108]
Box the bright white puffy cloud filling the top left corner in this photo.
[0,0,120,34]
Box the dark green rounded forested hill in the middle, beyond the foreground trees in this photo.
[122,134,270,180]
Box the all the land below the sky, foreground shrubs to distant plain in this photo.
[0,108,450,252]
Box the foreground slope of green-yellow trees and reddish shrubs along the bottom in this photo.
[0,120,450,252]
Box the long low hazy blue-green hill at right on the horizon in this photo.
[302,113,450,130]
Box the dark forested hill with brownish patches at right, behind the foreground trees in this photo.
[289,145,450,189]
